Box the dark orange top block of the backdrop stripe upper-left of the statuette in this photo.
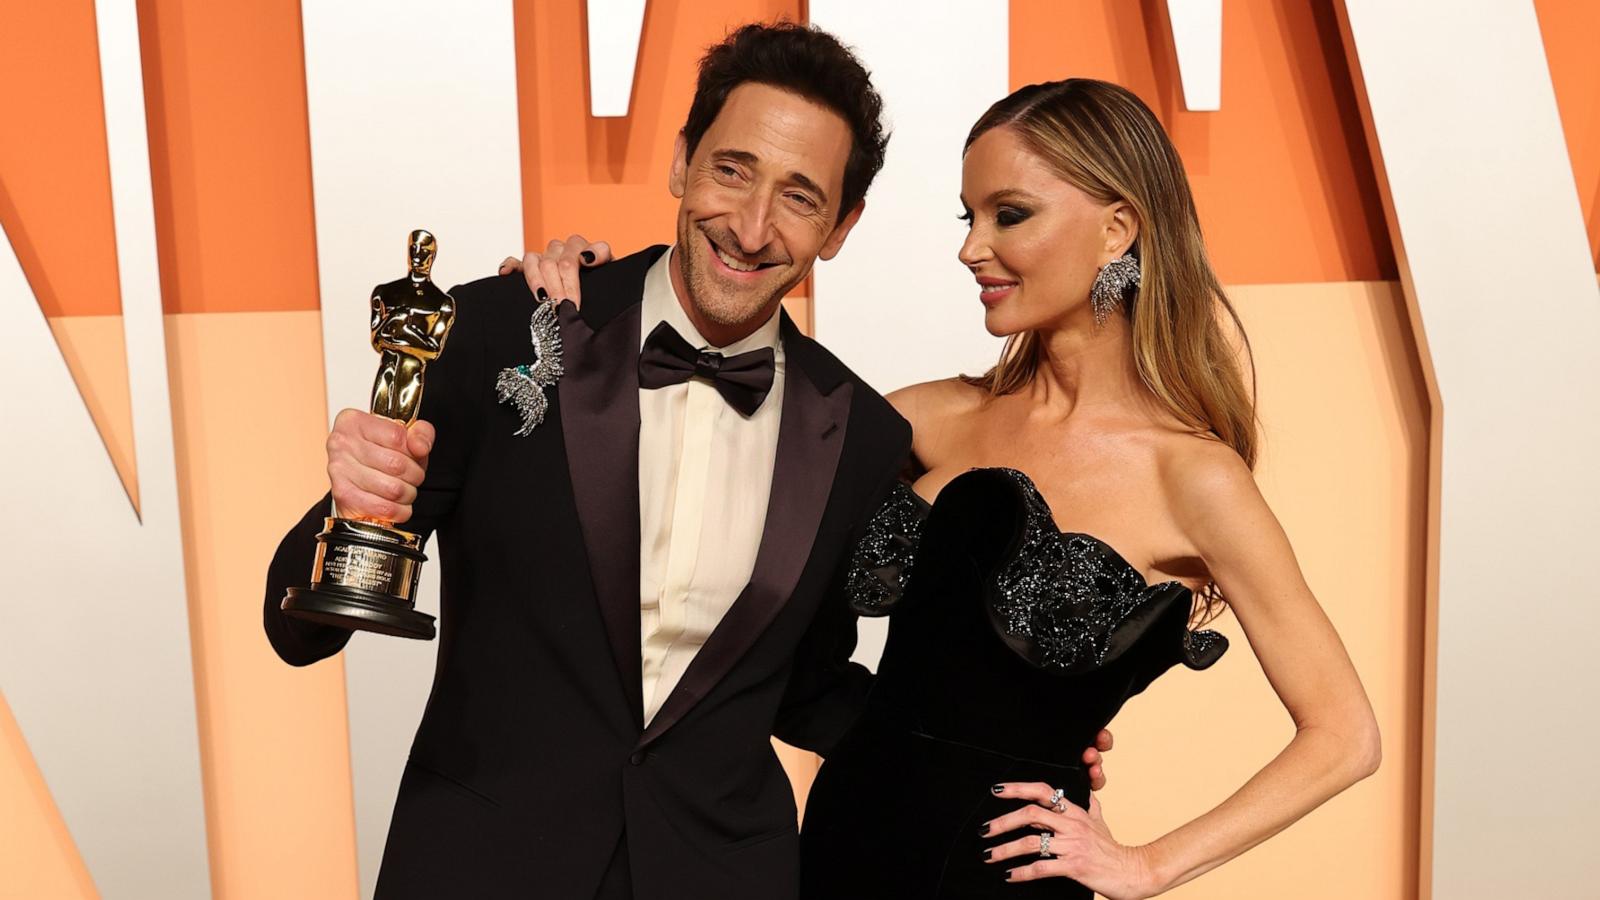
[139,0,318,312]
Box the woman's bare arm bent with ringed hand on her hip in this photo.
[990,444,1381,900]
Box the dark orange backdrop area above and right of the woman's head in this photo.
[1011,0,1398,285]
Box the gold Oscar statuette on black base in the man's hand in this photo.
[282,229,456,641]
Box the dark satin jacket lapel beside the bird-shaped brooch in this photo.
[557,303,645,727]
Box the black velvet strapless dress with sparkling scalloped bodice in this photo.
[800,469,1227,900]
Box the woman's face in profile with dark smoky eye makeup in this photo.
[960,127,1136,335]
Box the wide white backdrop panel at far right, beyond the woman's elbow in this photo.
[1346,0,1600,900]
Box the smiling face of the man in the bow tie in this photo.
[670,83,861,339]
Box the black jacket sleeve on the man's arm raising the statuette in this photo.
[262,279,492,666]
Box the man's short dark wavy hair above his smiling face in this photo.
[683,22,890,221]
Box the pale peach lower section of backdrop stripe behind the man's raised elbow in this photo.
[166,311,358,900]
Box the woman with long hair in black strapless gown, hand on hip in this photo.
[507,78,1379,900]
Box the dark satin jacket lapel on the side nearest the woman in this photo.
[638,354,853,746]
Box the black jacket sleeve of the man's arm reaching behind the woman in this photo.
[773,422,909,756]
